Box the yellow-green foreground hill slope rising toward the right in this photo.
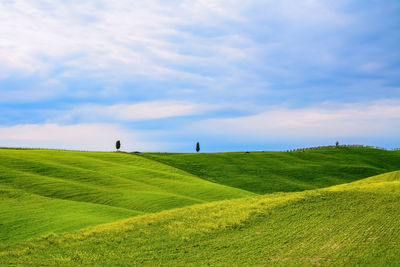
[0,172,400,266]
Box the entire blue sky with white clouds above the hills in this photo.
[0,0,400,152]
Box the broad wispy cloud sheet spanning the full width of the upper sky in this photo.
[0,0,400,103]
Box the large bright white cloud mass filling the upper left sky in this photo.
[0,0,346,79]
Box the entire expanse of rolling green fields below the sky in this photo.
[0,148,400,266]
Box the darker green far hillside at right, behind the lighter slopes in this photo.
[140,147,400,194]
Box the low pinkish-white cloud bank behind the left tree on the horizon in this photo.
[0,123,167,151]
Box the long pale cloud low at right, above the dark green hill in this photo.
[194,100,400,141]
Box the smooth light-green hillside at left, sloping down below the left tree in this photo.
[0,149,254,243]
